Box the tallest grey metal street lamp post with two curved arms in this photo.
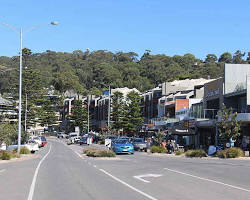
[0,22,58,153]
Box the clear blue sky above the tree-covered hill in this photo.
[0,0,250,59]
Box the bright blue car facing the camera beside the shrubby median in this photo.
[111,139,134,154]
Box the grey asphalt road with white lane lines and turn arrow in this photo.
[0,139,250,200]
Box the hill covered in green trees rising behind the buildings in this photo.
[0,48,249,94]
